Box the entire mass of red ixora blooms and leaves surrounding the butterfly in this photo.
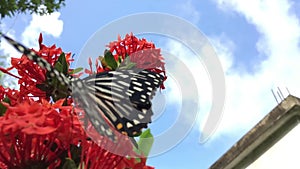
[0,34,166,169]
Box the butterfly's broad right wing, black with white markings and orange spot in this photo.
[84,70,163,137]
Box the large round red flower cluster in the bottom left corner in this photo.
[0,100,70,168]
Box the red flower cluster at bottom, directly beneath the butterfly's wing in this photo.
[82,126,154,169]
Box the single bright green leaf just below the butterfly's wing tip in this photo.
[138,129,154,157]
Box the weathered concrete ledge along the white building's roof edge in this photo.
[210,95,300,169]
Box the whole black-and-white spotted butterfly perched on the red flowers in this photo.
[0,33,164,141]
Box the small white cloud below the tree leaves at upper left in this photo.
[22,12,63,47]
